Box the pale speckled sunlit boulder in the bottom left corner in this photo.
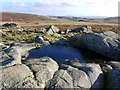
[2,64,38,88]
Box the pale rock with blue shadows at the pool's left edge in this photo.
[2,43,35,66]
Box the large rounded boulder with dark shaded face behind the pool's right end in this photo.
[69,31,120,60]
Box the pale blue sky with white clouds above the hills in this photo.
[0,0,119,17]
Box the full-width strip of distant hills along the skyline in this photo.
[0,12,120,25]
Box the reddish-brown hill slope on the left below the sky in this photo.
[0,12,65,22]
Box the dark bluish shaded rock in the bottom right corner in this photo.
[107,68,120,89]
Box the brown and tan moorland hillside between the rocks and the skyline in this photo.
[0,12,118,31]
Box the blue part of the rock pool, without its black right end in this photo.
[28,45,85,63]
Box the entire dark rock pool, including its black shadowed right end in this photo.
[28,45,112,64]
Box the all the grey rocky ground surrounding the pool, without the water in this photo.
[0,23,120,89]
